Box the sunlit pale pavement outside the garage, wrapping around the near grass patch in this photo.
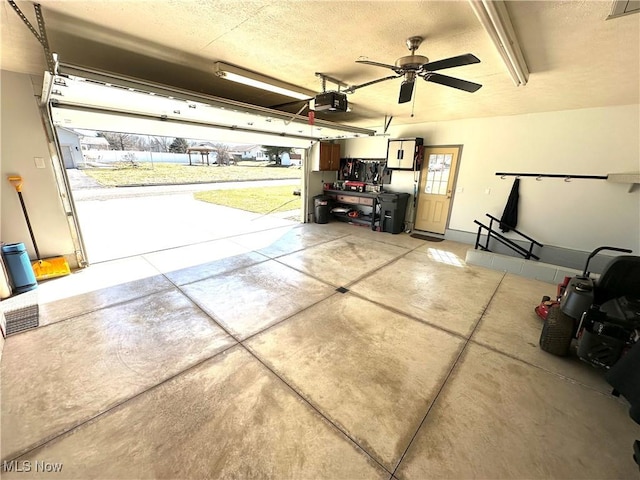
[67,170,300,263]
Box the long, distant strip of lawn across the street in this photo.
[83,162,302,187]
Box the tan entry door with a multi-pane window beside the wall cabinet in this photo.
[415,147,460,234]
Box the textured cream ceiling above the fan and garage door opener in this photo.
[1,0,640,127]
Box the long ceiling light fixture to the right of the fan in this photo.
[469,0,529,86]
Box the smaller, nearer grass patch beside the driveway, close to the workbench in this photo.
[193,185,302,214]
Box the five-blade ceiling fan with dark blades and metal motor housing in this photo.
[345,37,482,103]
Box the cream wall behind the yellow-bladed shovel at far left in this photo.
[0,71,73,259]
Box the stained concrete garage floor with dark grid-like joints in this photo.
[2,223,640,479]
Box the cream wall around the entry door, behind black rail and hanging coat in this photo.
[390,105,640,254]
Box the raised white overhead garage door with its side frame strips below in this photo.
[47,64,374,264]
